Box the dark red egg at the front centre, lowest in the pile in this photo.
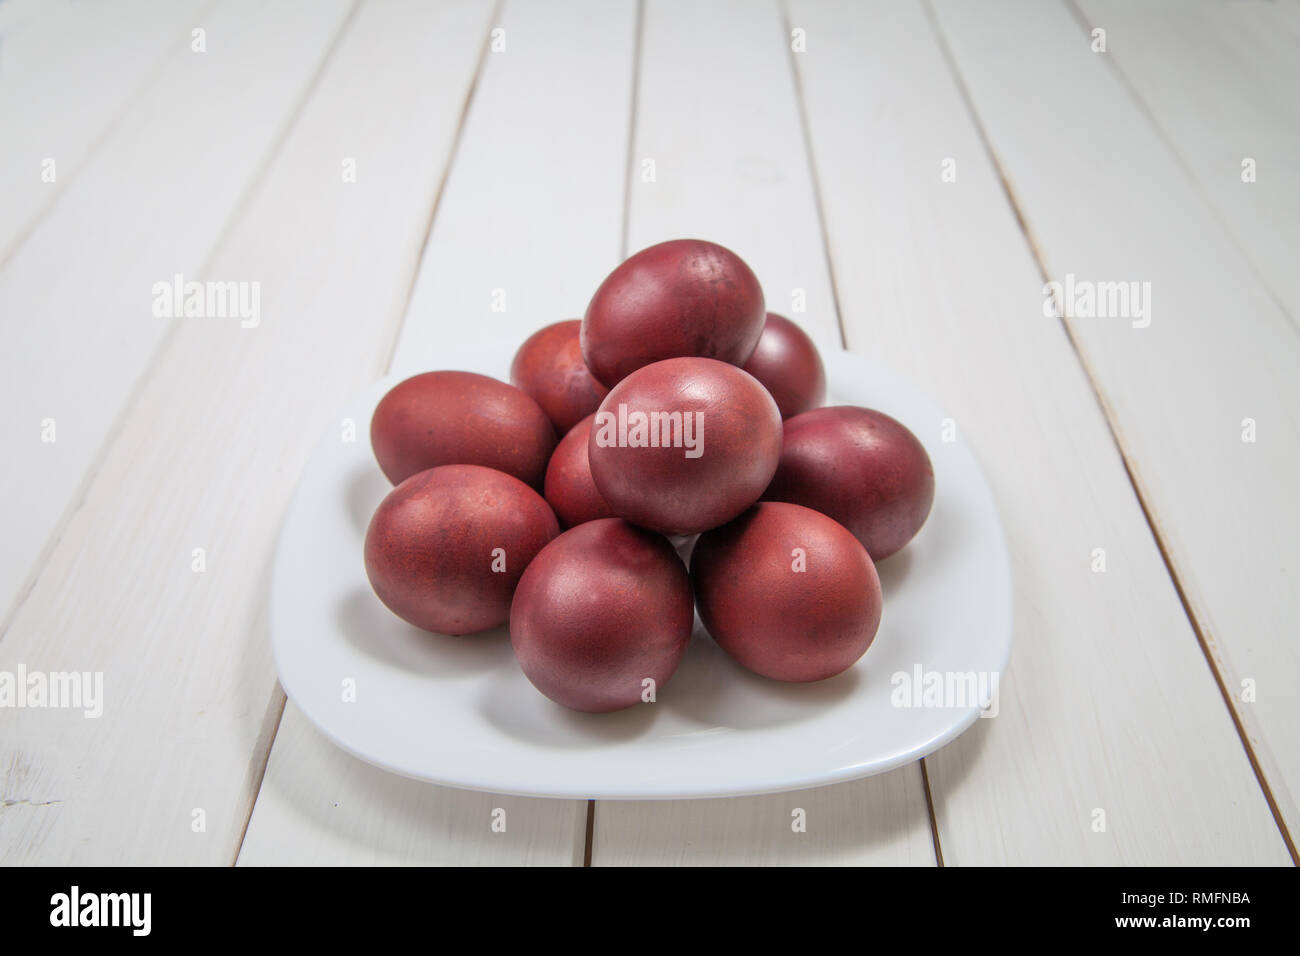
[510,518,694,713]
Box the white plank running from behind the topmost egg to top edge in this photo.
[628,0,840,342]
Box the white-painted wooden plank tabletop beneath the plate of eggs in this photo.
[0,0,1300,866]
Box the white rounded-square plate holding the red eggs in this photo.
[270,346,1011,800]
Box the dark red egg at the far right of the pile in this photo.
[763,405,935,561]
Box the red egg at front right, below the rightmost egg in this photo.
[690,502,881,682]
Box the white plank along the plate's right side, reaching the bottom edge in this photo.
[790,3,1287,865]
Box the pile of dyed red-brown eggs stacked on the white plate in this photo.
[365,239,935,711]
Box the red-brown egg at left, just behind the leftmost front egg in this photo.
[371,372,555,488]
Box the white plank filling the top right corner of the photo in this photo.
[1079,0,1300,328]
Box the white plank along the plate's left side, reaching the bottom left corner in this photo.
[0,3,493,865]
